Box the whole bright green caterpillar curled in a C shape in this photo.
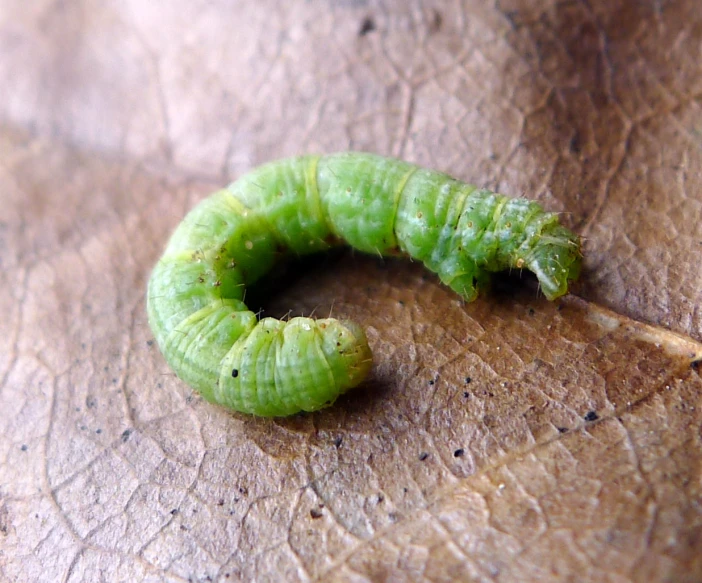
[147,152,581,417]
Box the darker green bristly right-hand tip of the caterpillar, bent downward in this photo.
[524,225,582,300]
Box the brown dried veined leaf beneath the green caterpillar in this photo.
[0,0,702,582]
